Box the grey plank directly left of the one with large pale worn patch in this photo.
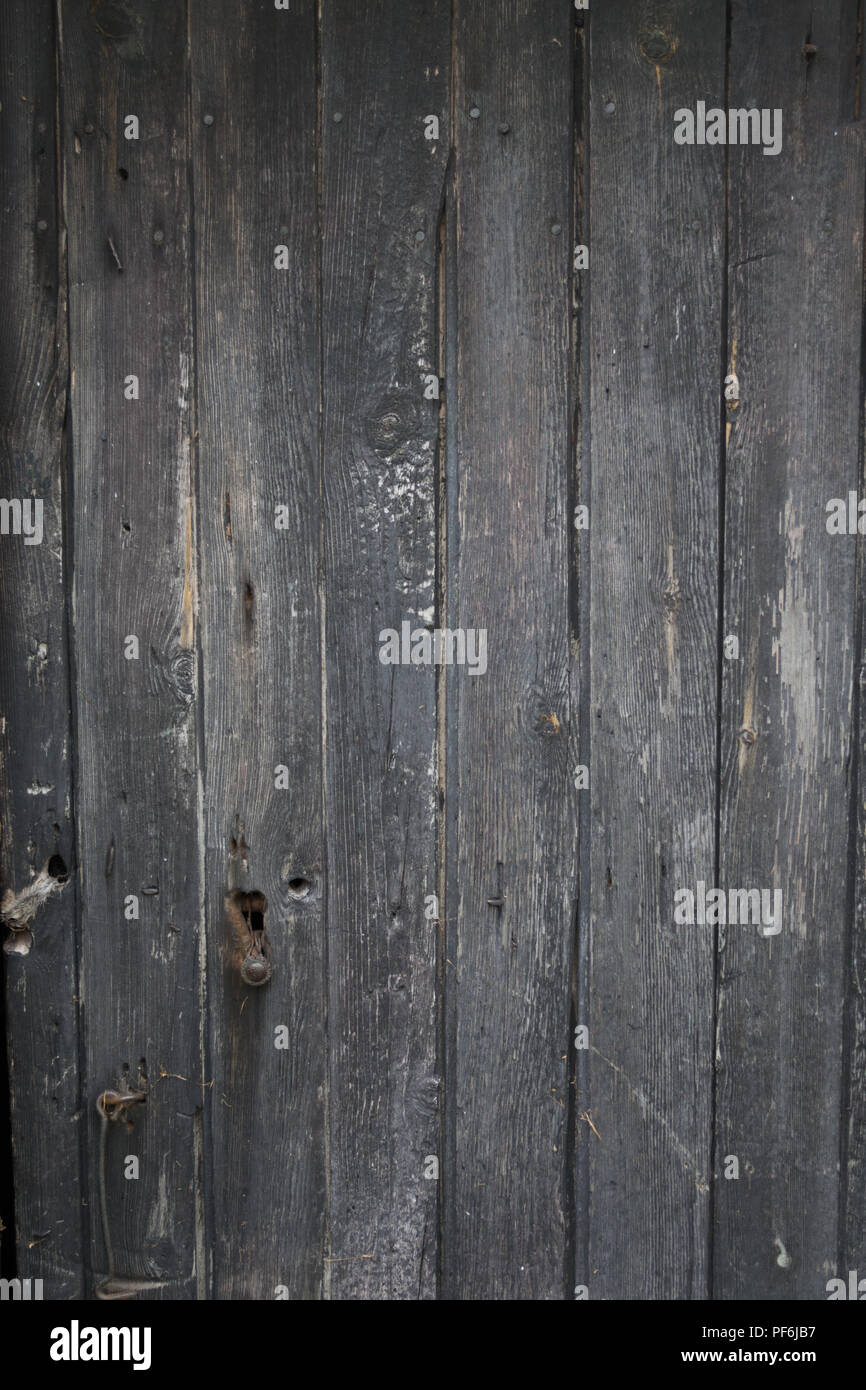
[577,0,726,1298]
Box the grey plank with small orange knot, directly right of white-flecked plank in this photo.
[445,0,578,1300]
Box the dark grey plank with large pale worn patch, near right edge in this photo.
[713,0,863,1298]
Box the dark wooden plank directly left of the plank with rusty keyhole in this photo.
[60,0,204,1298]
